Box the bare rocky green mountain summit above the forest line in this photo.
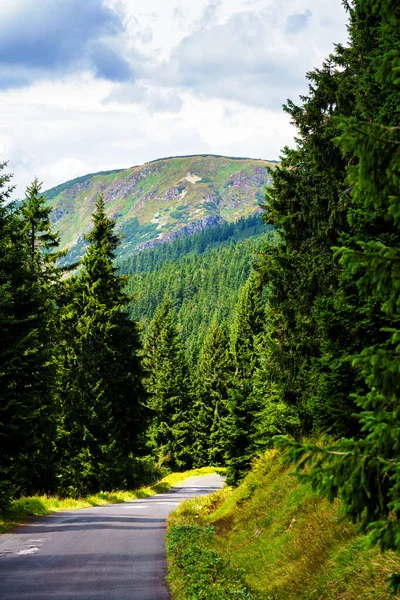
[45,155,276,260]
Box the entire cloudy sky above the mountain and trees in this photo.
[0,0,347,192]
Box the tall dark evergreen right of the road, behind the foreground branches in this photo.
[262,2,395,435]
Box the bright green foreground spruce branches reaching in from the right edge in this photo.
[281,55,400,600]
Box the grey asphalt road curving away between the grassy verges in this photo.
[0,475,223,600]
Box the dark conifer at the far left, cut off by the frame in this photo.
[0,171,61,504]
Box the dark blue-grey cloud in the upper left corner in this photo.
[0,0,132,89]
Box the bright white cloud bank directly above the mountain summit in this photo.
[0,92,292,198]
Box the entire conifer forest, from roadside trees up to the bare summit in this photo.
[0,0,400,589]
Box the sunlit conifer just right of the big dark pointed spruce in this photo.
[143,297,192,470]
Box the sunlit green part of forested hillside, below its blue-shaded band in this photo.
[127,234,272,357]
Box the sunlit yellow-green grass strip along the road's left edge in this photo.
[0,467,224,534]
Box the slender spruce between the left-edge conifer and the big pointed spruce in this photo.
[17,179,65,491]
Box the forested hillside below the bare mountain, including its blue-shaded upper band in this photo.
[118,215,275,358]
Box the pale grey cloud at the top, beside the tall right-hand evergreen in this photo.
[153,0,345,109]
